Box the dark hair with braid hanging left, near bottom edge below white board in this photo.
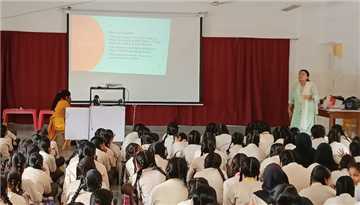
[71,169,102,203]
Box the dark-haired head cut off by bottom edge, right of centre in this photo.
[192,185,218,205]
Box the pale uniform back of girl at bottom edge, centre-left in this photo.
[149,179,189,205]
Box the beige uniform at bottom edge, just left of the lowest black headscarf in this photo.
[224,178,262,205]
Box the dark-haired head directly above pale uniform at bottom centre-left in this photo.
[166,157,188,186]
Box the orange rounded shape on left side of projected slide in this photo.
[70,15,105,71]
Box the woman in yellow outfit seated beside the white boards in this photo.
[48,90,71,140]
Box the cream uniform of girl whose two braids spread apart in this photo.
[132,167,166,205]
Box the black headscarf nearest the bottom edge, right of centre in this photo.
[262,163,289,193]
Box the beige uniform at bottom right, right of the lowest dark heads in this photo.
[299,182,336,205]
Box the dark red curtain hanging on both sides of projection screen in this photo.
[0,31,290,126]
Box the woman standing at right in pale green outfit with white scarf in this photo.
[288,69,319,135]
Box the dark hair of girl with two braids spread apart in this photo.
[133,150,166,203]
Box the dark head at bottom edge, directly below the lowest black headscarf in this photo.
[269,184,300,205]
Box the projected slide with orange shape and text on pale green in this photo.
[69,15,171,75]
